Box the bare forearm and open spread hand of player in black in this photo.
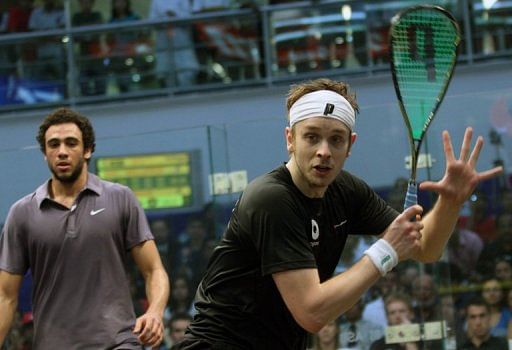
[413,128,503,262]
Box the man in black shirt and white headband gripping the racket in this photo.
[177,79,501,350]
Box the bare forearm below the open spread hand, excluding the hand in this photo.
[415,197,460,263]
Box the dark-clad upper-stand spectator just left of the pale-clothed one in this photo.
[107,0,140,92]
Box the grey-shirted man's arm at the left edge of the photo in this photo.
[0,270,23,347]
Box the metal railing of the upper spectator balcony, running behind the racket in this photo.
[0,0,512,113]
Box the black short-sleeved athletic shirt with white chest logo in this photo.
[186,165,398,350]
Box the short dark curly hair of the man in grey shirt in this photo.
[36,107,96,153]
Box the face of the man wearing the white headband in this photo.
[286,117,355,197]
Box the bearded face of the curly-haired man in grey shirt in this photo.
[45,123,91,183]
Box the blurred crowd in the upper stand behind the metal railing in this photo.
[0,0,512,104]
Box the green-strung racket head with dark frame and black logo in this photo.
[389,5,461,148]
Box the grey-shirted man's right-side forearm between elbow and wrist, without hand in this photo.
[145,267,170,316]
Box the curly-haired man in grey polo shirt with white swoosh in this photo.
[0,108,169,350]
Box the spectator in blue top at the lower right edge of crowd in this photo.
[482,278,512,337]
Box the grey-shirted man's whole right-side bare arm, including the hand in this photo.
[131,240,170,346]
